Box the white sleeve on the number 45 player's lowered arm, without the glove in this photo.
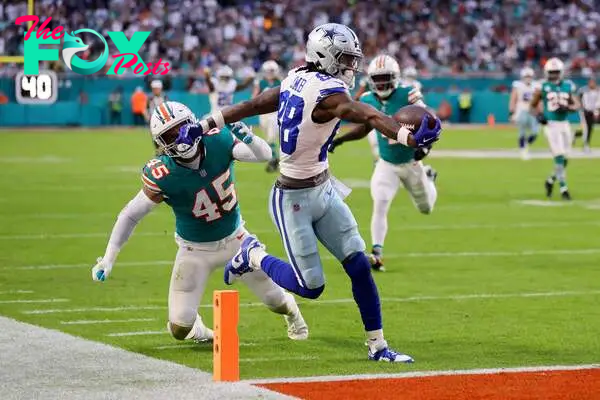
[103,190,158,265]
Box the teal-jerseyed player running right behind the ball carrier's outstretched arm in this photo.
[330,55,437,271]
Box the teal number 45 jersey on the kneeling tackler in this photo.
[142,129,242,243]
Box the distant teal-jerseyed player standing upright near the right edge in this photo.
[531,58,580,200]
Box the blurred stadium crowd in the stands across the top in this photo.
[0,0,600,75]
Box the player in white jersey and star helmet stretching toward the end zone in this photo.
[200,23,441,363]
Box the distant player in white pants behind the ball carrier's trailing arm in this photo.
[252,60,281,172]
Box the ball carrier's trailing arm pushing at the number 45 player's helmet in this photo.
[200,86,279,132]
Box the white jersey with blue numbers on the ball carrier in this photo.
[277,69,350,179]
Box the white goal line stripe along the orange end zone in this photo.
[243,364,600,385]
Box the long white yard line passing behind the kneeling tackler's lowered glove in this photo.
[7,248,600,270]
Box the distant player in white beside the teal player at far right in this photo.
[508,67,539,160]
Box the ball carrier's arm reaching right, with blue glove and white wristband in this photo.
[312,92,441,147]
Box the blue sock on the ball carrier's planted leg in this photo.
[342,252,382,332]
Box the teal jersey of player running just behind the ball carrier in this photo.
[360,86,415,164]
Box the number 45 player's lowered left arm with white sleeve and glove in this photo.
[92,186,163,281]
